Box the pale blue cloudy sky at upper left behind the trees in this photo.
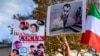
[0,0,36,40]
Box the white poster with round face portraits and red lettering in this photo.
[12,19,45,56]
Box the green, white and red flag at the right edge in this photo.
[81,3,100,52]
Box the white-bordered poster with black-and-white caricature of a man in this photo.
[46,0,86,35]
